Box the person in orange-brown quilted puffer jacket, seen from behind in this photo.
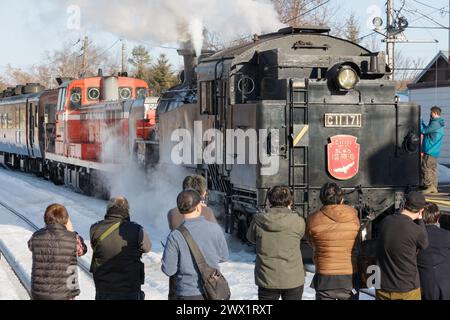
[307,183,360,300]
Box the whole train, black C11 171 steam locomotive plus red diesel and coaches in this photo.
[0,27,421,238]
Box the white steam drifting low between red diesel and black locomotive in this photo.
[101,122,189,234]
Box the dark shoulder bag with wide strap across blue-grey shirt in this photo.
[177,225,231,300]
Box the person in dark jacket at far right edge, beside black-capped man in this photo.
[417,203,450,300]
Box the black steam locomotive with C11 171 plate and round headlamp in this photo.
[157,28,420,236]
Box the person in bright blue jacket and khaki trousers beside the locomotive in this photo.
[421,107,445,194]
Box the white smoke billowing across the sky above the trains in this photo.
[51,0,282,55]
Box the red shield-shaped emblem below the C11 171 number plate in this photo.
[328,135,360,180]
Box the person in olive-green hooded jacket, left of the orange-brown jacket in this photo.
[247,186,305,300]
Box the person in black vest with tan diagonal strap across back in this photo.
[90,197,151,300]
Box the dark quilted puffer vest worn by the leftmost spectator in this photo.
[28,224,80,300]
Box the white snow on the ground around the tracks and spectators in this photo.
[0,169,320,300]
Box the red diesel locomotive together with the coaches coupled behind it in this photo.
[0,75,156,194]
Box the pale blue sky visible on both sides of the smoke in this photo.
[0,0,449,72]
